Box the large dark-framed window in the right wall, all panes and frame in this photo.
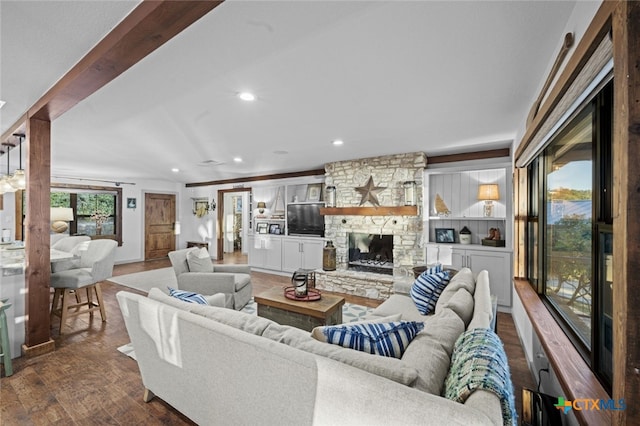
[527,83,614,390]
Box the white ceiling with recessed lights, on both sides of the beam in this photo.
[0,0,575,183]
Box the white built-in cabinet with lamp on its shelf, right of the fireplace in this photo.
[423,164,513,309]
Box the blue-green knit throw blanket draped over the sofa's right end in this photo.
[445,328,517,426]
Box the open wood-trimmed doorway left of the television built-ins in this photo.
[217,188,251,263]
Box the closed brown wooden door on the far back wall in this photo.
[144,194,176,260]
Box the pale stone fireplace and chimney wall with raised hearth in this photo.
[316,152,426,300]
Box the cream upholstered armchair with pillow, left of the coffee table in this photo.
[169,247,253,310]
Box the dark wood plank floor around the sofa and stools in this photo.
[0,256,534,425]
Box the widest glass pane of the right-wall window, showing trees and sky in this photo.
[544,108,593,348]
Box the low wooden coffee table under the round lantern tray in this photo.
[254,287,344,331]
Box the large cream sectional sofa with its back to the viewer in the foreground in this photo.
[117,269,510,426]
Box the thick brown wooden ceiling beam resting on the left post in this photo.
[0,0,222,141]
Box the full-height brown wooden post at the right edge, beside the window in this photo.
[612,1,640,425]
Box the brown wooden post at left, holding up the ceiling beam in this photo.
[22,118,55,356]
